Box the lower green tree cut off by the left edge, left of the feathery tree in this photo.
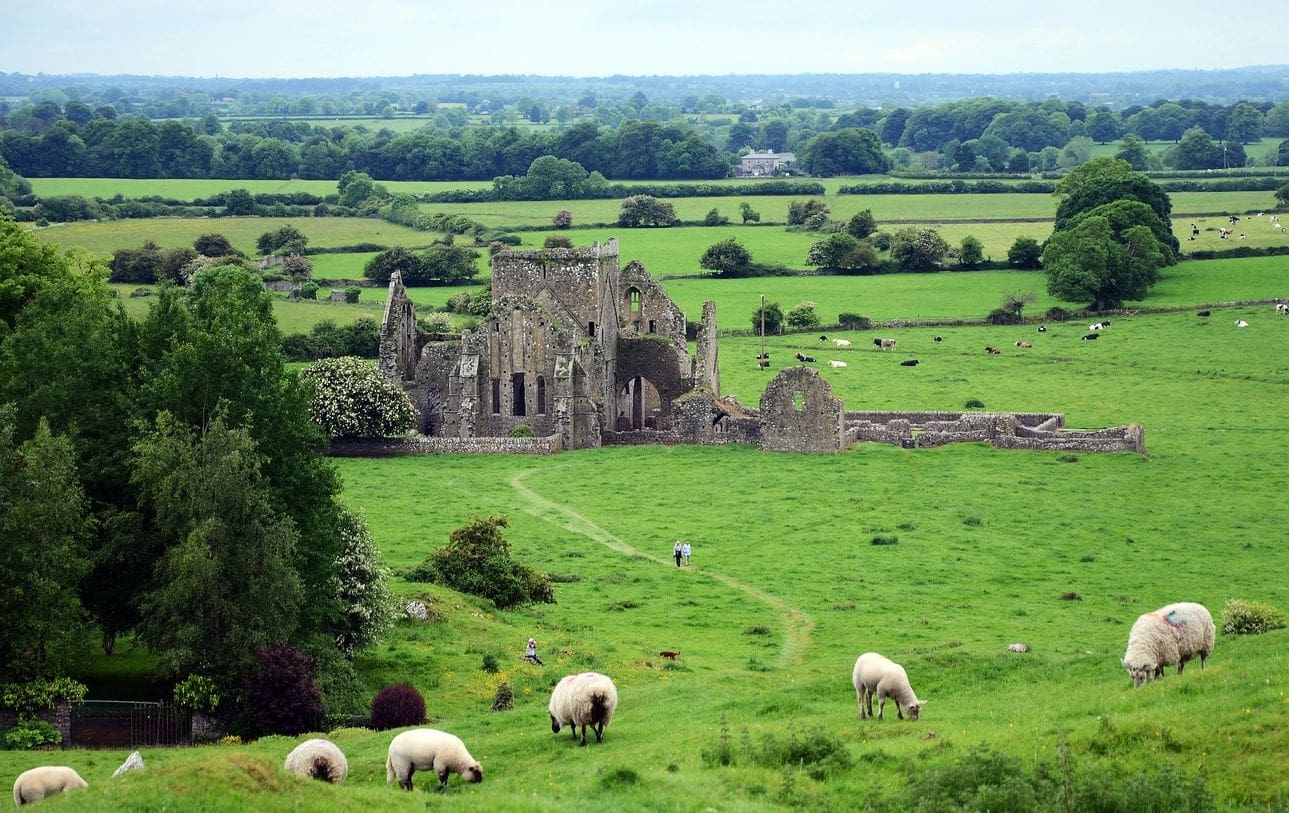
[0,405,90,680]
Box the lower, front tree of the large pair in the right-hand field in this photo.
[1043,214,1165,311]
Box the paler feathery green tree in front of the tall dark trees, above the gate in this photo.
[134,412,303,682]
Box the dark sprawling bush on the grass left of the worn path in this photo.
[407,517,556,608]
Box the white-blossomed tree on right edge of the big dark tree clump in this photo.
[331,508,393,657]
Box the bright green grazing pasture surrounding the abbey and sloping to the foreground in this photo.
[10,300,1289,810]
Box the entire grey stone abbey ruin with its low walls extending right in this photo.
[376,240,1146,454]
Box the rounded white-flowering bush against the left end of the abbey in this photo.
[304,356,416,438]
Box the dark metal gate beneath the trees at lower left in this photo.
[71,700,192,749]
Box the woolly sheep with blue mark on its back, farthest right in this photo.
[1123,602,1214,687]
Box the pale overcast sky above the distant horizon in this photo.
[0,0,1289,77]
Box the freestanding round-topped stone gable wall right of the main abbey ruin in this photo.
[761,366,846,452]
